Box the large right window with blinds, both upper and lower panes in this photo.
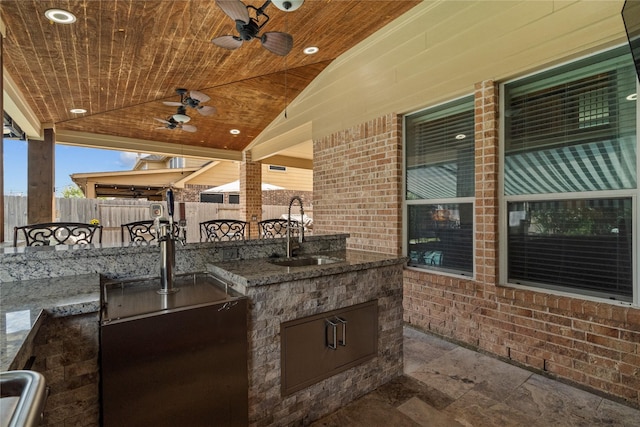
[503,48,638,301]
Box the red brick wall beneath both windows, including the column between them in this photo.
[403,82,640,407]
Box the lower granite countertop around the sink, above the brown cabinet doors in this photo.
[208,250,407,293]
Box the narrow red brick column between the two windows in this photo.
[474,80,500,285]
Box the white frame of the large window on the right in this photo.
[498,45,640,307]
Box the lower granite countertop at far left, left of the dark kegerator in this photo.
[0,274,100,371]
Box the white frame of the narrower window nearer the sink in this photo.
[401,92,477,280]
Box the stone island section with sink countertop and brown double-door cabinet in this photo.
[208,250,406,426]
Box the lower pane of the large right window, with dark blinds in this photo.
[507,198,633,301]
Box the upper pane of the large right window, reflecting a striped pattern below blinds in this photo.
[504,48,637,195]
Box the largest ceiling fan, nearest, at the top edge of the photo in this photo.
[211,0,301,56]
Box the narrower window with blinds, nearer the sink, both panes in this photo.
[405,96,475,276]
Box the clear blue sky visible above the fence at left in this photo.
[4,139,137,196]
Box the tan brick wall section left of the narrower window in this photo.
[313,114,402,255]
